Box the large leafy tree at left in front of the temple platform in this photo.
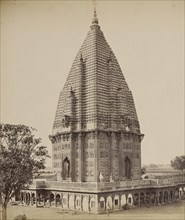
[0,124,49,220]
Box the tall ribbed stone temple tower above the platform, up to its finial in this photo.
[50,11,143,182]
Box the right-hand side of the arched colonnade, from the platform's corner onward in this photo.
[99,187,185,211]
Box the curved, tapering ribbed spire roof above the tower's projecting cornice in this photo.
[53,22,140,133]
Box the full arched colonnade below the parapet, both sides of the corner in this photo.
[20,186,185,213]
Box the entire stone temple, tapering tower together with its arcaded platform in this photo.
[21,8,185,213]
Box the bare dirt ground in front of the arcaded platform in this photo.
[3,200,185,220]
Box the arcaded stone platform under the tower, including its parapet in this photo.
[21,174,185,213]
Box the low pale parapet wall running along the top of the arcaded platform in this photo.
[30,173,185,192]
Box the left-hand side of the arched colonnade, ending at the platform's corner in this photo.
[20,190,97,212]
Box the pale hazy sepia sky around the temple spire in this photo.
[1,0,184,164]
